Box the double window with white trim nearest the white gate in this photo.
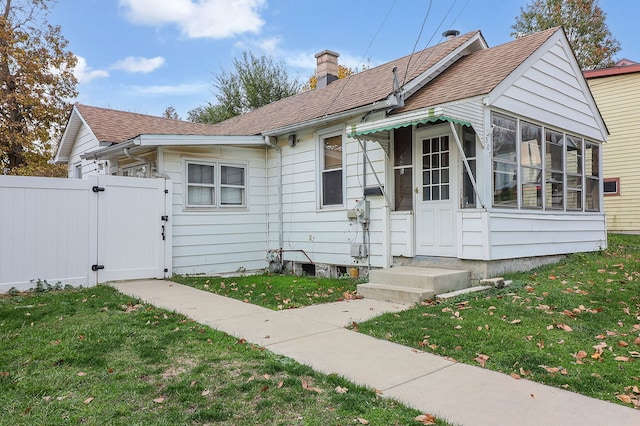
[185,160,247,209]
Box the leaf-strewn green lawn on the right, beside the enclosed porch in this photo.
[358,235,640,408]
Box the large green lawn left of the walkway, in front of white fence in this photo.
[0,286,446,425]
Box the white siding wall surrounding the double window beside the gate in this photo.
[164,146,268,275]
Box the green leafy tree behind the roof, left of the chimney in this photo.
[188,52,300,124]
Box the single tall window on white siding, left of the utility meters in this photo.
[321,134,344,206]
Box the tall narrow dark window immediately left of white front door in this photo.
[393,126,413,211]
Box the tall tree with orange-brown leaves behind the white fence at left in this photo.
[0,0,77,175]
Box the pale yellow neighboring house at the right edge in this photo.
[584,59,640,233]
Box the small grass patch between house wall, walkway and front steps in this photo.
[172,274,358,310]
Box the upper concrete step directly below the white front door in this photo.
[369,266,471,294]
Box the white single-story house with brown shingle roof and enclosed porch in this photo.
[56,28,607,278]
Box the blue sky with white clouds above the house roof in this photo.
[48,0,640,119]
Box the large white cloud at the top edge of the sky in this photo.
[120,0,266,39]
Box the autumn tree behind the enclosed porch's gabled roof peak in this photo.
[511,0,620,70]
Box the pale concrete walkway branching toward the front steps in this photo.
[112,280,640,426]
